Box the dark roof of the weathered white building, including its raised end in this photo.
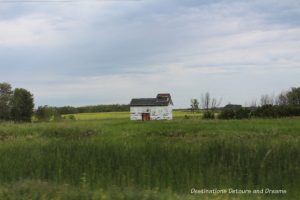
[130,94,173,106]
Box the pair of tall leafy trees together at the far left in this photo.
[0,83,34,122]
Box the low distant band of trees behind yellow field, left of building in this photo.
[54,104,130,115]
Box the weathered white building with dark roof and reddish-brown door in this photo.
[130,93,173,121]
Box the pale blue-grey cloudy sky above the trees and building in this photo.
[0,0,300,108]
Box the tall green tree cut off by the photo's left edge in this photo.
[0,83,12,121]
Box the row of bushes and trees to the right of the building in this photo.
[190,87,300,119]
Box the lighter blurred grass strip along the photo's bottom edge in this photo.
[0,180,285,200]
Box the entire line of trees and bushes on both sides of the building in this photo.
[0,79,300,122]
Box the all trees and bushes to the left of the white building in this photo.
[0,82,130,122]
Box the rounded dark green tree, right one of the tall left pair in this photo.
[11,88,34,122]
